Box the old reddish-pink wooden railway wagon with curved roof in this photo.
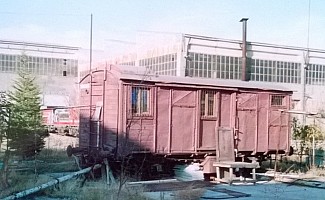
[72,65,292,178]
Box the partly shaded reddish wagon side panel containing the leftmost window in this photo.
[118,83,155,152]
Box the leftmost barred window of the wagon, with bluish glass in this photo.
[131,87,150,115]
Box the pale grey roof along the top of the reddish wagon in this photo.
[110,66,293,92]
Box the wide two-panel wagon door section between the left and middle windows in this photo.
[156,87,196,153]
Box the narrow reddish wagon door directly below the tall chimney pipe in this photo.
[237,93,257,151]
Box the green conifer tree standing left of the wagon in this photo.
[7,72,48,158]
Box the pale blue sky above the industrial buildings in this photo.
[0,0,325,60]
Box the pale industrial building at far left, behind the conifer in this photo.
[0,40,79,127]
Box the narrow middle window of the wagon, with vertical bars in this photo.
[201,90,216,117]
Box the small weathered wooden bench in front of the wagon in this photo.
[213,161,259,184]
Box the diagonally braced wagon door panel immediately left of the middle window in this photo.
[171,89,196,152]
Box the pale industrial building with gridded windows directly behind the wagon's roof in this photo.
[113,23,325,125]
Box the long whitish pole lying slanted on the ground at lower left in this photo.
[3,164,101,200]
